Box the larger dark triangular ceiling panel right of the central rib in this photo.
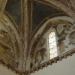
[32,1,67,31]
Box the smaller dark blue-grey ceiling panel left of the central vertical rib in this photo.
[5,0,21,25]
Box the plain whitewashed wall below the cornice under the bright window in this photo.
[31,54,75,75]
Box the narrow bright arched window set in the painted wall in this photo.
[48,31,58,59]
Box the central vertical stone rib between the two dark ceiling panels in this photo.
[21,0,30,72]
